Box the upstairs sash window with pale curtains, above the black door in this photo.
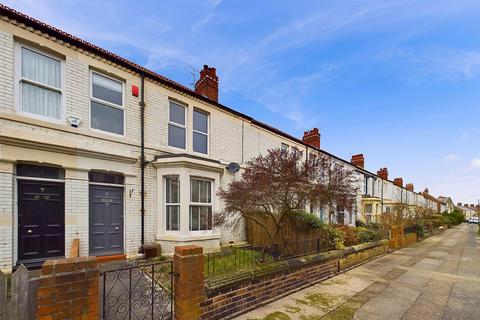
[18,46,62,120]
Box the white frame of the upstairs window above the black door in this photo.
[14,42,66,125]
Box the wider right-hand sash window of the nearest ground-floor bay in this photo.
[190,179,212,231]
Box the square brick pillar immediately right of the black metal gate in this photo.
[173,245,205,320]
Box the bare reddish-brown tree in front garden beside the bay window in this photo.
[215,149,356,250]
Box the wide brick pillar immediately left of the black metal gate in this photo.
[37,257,99,320]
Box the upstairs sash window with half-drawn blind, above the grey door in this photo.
[90,72,124,135]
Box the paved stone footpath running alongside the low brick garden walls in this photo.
[237,225,480,320]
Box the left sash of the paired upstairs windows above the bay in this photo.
[168,101,187,149]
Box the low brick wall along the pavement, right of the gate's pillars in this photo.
[200,241,388,320]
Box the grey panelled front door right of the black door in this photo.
[89,185,123,256]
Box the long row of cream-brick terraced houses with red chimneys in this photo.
[0,5,442,269]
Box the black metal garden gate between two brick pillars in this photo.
[100,260,173,320]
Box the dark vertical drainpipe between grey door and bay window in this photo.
[139,73,146,253]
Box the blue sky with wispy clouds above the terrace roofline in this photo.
[4,0,480,203]
